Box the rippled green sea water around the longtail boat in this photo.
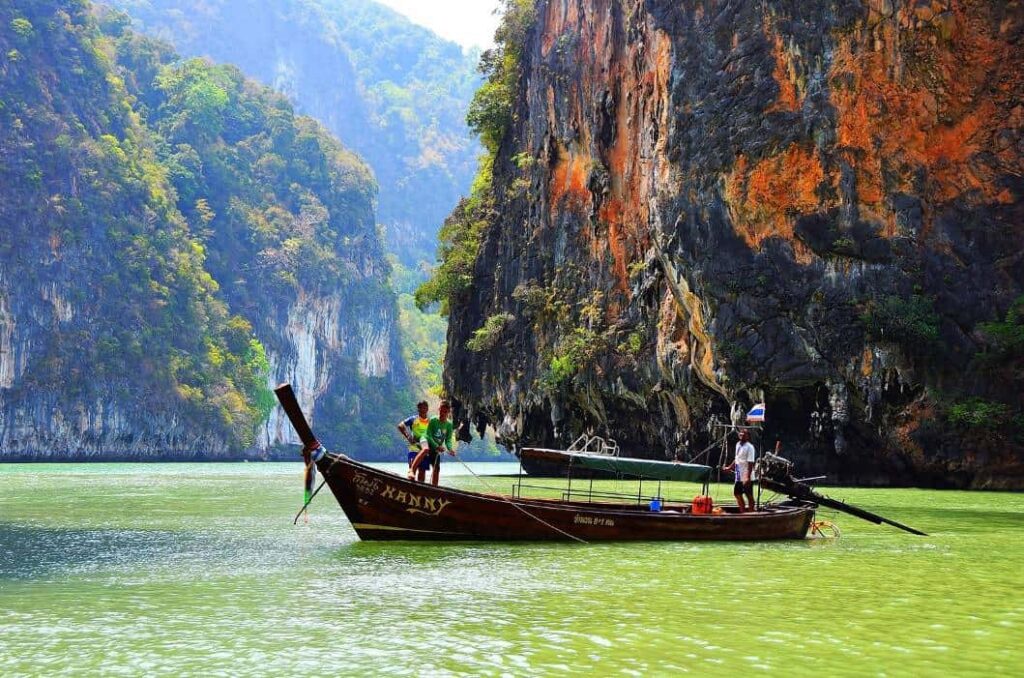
[0,464,1024,676]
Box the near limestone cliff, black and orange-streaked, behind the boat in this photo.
[445,0,1024,486]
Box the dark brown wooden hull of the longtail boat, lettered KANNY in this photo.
[317,454,814,542]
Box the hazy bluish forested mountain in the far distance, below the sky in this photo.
[109,0,478,269]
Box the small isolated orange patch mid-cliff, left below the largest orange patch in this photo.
[725,143,827,260]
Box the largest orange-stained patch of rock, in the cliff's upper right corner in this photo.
[829,1,1024,231]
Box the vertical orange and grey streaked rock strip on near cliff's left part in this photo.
[541,0,671,295]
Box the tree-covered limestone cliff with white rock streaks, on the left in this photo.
[0,0,410,460]
